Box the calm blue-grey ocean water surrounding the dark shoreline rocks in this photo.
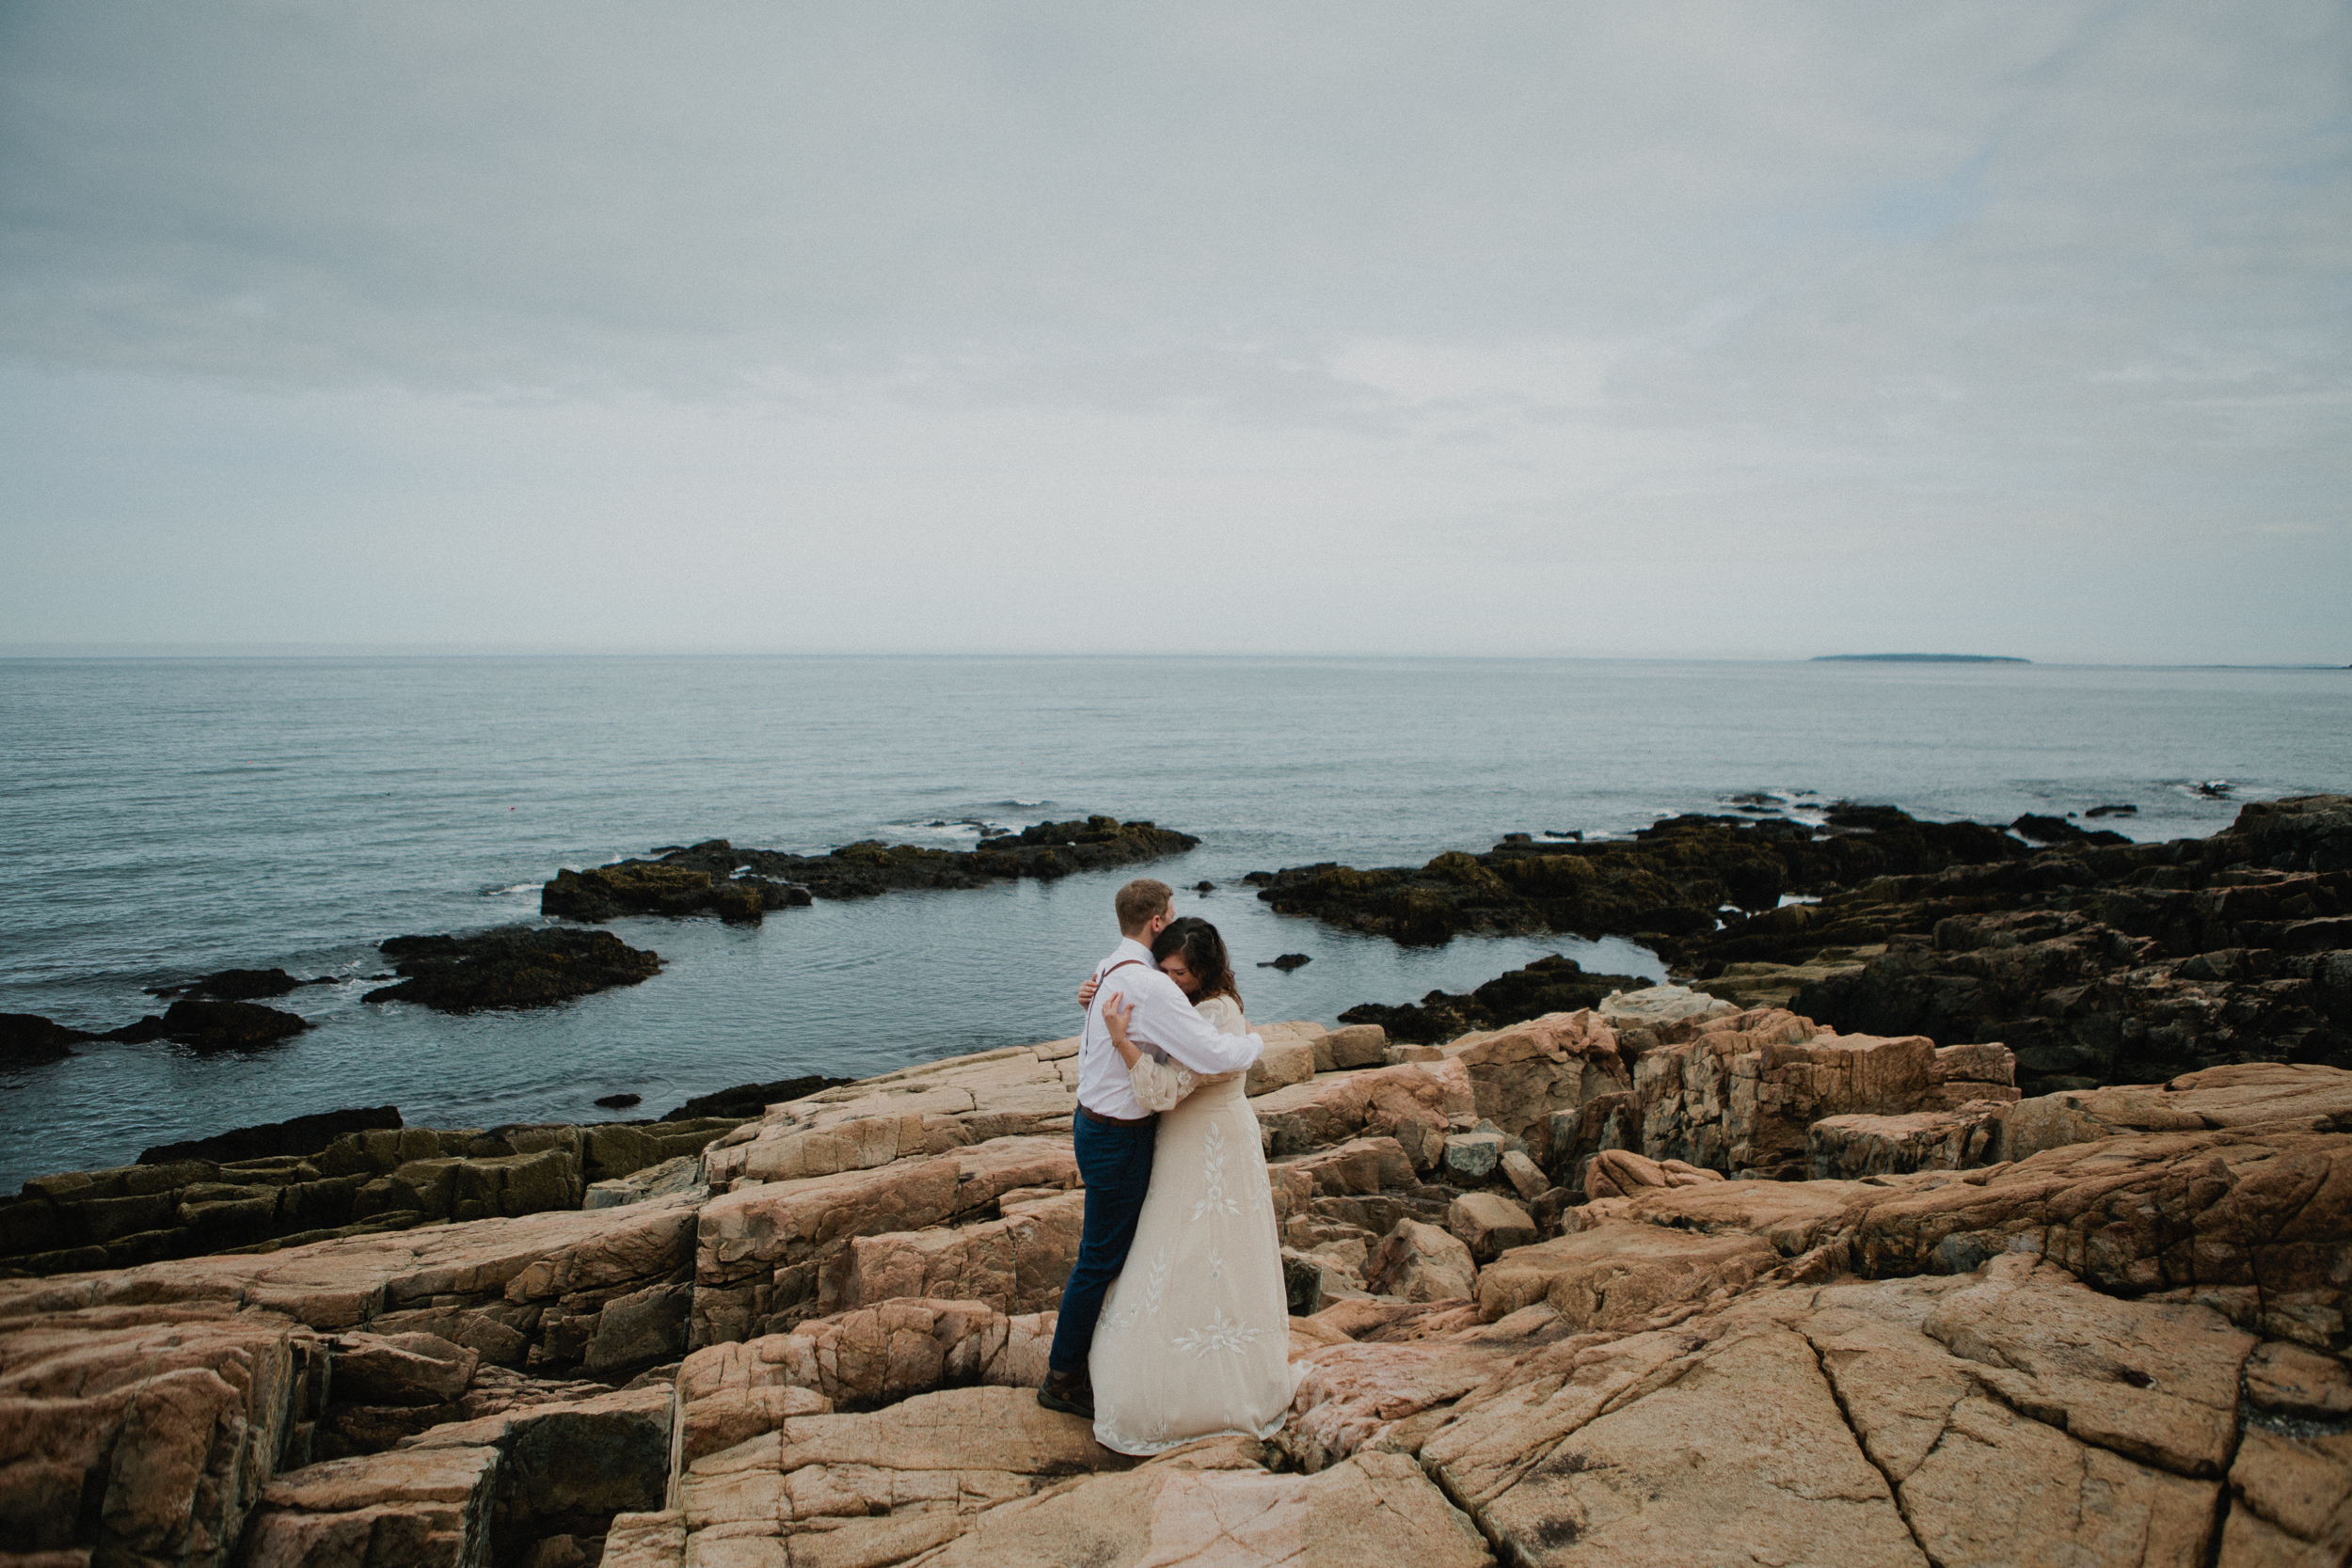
[0,658,2352,1190]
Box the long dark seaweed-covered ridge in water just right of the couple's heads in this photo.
[1259,804,2032,952]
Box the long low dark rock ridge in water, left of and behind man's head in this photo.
[539,816,1200,922]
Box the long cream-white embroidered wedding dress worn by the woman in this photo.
[1089,997,1294,1455]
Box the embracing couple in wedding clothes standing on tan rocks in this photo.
[1038,879,1292,1455]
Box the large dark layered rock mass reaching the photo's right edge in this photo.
[1677,795,2352,1093]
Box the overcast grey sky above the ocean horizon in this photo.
[0,0,2352,663]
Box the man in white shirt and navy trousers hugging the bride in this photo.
[1038,877,1265,1420]
